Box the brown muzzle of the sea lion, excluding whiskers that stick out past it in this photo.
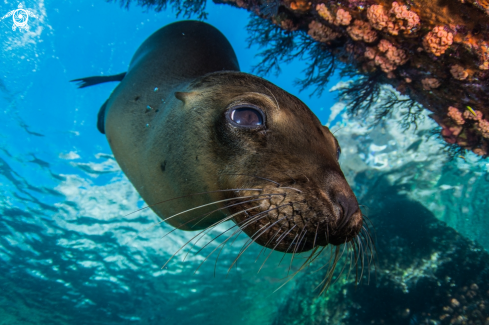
[229,182,364,253]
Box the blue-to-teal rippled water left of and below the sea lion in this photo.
[0,1,342,324]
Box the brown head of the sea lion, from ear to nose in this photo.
[170,72,363,253]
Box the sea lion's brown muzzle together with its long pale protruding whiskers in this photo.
[157,174,375,293]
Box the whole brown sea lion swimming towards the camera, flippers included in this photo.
[74,21,364,253]
